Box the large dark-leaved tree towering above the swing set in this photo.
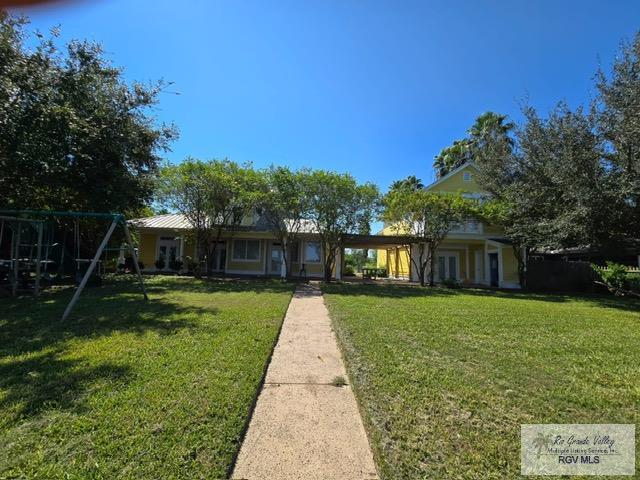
[0,11,177,215]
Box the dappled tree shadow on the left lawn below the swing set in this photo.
[0,278,228,425]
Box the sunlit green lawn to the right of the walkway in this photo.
[324,285,640,480]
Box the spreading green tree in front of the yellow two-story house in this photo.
[382,189,475,286]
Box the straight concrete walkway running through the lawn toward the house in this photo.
[231,285,378,480]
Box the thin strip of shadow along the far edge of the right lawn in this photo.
[322,283,640,313]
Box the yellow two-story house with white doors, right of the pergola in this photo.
[377,163,520,288]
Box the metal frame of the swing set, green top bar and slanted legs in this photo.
[0,210,149,321]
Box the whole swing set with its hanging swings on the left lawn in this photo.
[0,210,148,320]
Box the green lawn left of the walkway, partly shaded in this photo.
[0,277,292,479]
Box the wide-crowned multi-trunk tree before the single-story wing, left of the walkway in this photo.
[158,158,259,275]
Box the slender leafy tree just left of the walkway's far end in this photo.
[258,166,308,277]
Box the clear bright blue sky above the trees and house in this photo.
[17,0,640,190]
